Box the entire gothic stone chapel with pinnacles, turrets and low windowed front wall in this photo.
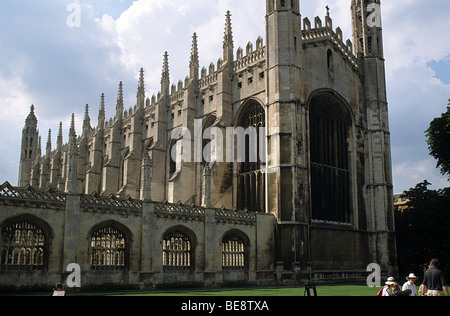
[0,0,397,288]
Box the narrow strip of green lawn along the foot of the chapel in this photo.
[118,285,379,297]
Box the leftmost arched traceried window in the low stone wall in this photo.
[0,219,49,270]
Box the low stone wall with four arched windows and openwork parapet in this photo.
[0,183,275,291]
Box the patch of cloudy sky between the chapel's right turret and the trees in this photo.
[382,0,450,191]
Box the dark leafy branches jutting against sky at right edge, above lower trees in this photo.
[425,99,450,179]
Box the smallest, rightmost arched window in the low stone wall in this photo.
[222,234,248,270]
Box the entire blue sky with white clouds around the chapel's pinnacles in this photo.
[0,0,450,192]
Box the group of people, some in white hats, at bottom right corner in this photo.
[379,259,450,296]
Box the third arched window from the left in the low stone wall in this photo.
[163,230,194,270]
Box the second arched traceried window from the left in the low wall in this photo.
[90,225,128,270]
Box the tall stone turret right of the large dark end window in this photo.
[351,0,396,275]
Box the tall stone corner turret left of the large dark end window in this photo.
[265,0,308,269]
